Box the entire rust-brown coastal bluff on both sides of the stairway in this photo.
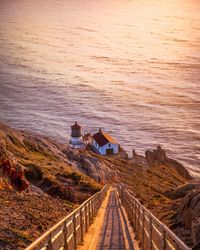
[0,124,200,249]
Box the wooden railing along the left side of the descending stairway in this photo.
[26,185,108,250]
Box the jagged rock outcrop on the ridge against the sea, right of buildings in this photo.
[145,146,192,180]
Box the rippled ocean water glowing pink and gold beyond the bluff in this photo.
[0,0,200,175]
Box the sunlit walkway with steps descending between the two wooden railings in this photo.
[78,189,139,250]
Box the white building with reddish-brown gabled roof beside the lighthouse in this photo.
[92,129,119,155]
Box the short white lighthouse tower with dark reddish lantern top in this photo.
[69,122,83,149]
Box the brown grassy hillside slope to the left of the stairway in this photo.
[0,124,102,249]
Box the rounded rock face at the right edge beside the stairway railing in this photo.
[182,188,200,244]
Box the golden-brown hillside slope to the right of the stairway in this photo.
[97,150,200,246]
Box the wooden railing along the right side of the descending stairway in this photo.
[117,185,191,250]
